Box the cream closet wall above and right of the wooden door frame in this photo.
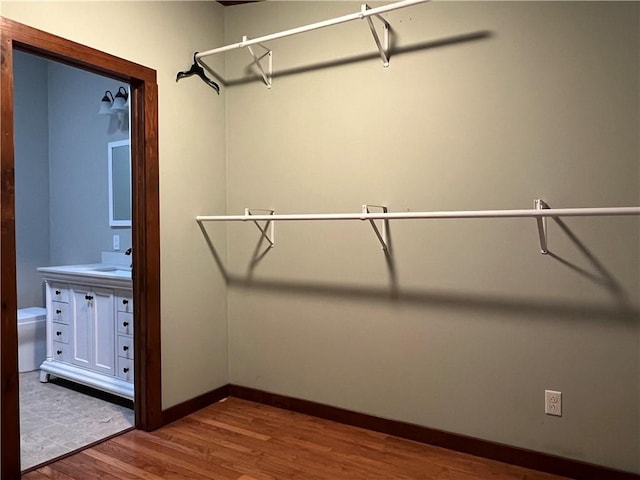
[1,1,228,408]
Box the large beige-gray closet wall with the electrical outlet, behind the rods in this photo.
[225,2,640,472]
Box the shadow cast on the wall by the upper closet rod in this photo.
[200,30,493,87]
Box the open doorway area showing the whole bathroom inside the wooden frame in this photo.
[13,50,135,471]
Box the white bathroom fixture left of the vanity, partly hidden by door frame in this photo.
[18,307,47,373]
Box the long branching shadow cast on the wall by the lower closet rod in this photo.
[198,217,640,323]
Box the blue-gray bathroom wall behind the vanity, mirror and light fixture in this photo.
[49,62,131,265]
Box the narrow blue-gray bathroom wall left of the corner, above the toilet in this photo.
[14,52,50,308]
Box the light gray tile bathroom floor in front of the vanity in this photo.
[20,371,134,470]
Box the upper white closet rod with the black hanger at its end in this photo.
[196,0,430,60]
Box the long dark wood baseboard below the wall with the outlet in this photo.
[227,385,640,480]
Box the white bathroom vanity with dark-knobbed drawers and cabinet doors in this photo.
[38,264,134,400]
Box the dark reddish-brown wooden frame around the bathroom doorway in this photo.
[0,17,162,479]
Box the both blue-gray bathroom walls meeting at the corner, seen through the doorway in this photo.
[14,52,131,307]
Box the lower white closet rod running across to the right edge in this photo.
[196,207,640,222]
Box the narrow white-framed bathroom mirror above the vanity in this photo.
[108,140,131,227]
